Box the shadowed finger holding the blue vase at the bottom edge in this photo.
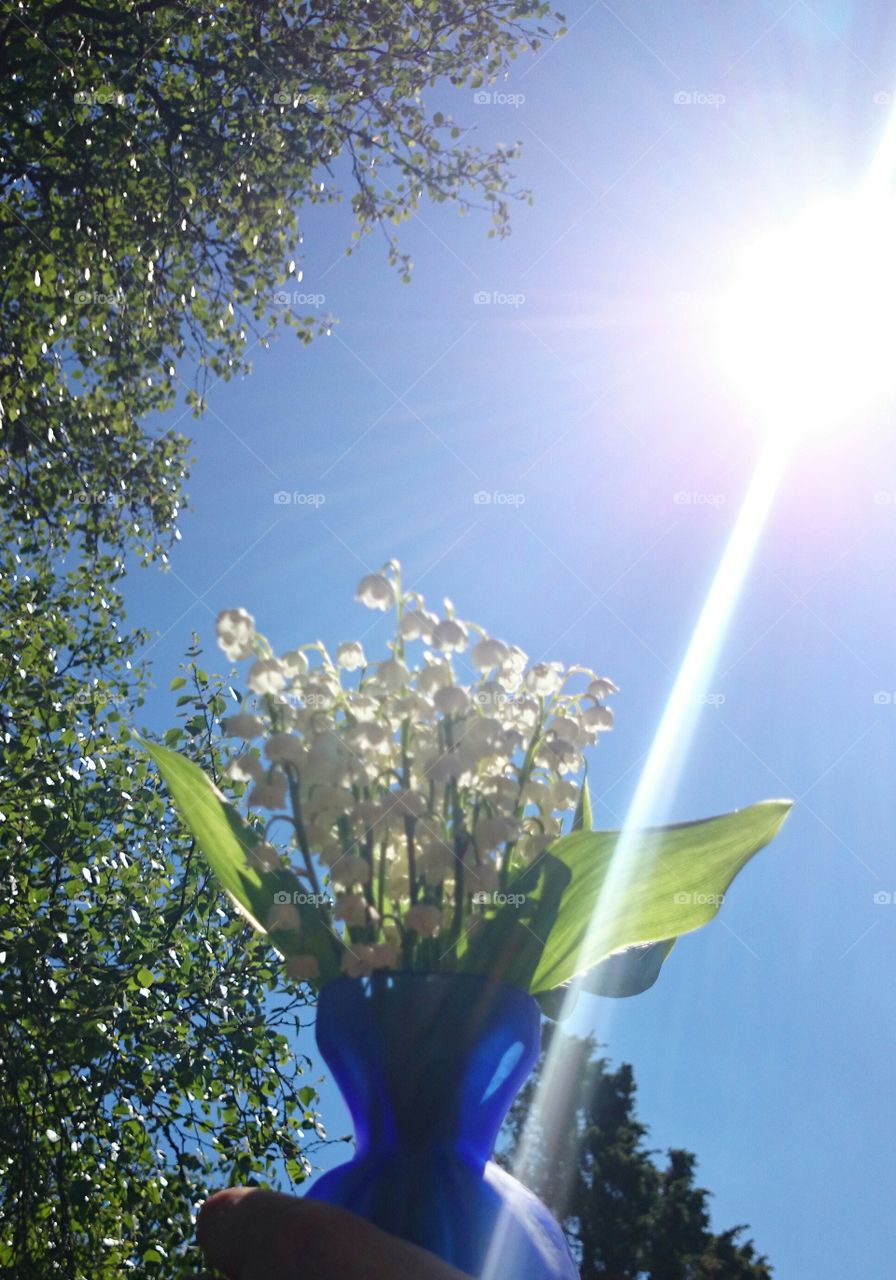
[196,1188,468,1280]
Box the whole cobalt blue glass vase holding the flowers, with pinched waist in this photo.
[308,972,579,1280]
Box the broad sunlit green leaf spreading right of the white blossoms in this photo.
[530,800,792,992]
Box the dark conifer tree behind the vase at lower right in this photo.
[500,1028,772,1280]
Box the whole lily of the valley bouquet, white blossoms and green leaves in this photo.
[146,561,790,1007]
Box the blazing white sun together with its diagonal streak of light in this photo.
[483,99,896,1280]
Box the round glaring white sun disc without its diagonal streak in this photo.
[717,196,896,436]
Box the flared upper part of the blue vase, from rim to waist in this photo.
[317,973,539,1165]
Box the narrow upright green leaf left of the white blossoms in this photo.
[141,740,342,982]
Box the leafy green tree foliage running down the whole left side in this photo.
[0,0,560,1280]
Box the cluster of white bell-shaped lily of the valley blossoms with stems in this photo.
[218,561,617,978]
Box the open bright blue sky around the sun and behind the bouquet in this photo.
[128,0,896,1280]
